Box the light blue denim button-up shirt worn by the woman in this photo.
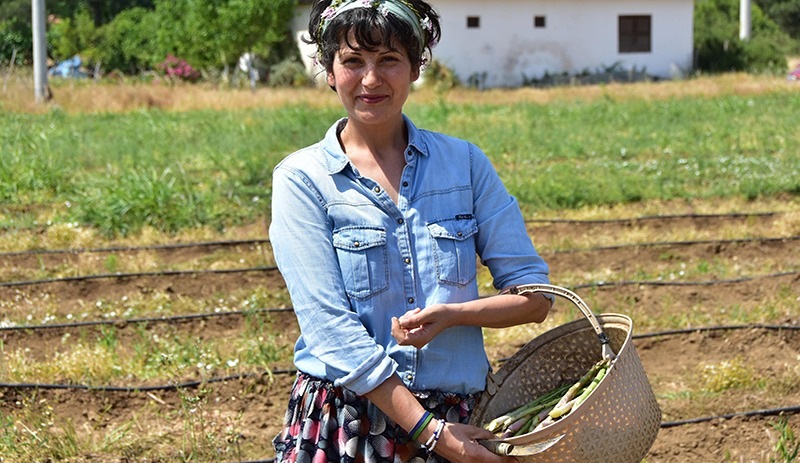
[269,116,548,394]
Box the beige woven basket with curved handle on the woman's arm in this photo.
[470,285,661,463]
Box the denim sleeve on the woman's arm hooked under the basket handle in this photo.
[471,145,550,289]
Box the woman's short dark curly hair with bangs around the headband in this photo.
[304,0,441,72]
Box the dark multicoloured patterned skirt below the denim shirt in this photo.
[273,373,478,463]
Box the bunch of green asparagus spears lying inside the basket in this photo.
[484,359,610,439]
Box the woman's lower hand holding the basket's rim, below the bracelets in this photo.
[431,422,517,463]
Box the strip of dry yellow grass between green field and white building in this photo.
[0,72,800,113]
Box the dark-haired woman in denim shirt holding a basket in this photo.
[270,0,551,463]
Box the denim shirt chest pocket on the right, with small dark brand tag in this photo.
[428,218,478,286]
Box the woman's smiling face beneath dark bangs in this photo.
[328,32,419,124]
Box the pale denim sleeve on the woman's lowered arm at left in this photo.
[269,163,397,395]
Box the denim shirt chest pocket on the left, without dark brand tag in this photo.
[333,227,389,299]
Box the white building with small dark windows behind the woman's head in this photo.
[292,0,694,87]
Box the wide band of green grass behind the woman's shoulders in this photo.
[0,90,800,237]
